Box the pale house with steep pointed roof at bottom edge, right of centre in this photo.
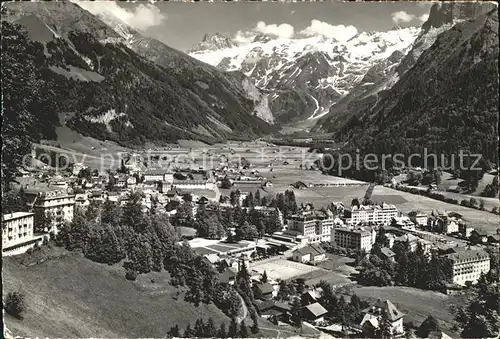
[360,299,405,337]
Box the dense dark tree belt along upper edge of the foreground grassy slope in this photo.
[56,193,241,316]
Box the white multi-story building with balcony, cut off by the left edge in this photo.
[2,212,43,256]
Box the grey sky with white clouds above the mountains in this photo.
[74,1,431,51]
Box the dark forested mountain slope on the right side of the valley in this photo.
[330,9,499,162]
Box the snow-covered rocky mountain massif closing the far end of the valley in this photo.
[190,28,419,128]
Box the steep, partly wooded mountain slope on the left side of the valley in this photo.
[2,2,273,144]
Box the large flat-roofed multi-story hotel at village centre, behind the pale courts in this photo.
[285,210,334,243]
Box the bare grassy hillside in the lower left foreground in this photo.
[3,248,229,337]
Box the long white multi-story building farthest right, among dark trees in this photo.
[446,250,490,285]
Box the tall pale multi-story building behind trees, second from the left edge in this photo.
[26,190,75,235]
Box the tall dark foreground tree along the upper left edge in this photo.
[1,21,58,192]
